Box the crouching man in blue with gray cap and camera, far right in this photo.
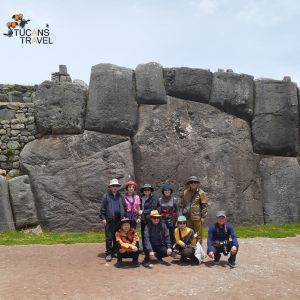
[207,211,239,268]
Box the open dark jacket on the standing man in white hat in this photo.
[100,191,127,221]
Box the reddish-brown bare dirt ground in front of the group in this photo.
[0,236,300,300]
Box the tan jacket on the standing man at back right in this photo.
[179,188,208,221]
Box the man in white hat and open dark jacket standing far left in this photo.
[100,178,127,262]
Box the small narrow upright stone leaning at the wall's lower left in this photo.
[8,175,38,229]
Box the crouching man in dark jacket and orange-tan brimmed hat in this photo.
[143,210,172,268]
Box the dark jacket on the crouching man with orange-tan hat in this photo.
[144,221,171,252]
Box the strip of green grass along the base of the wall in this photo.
[0,224,300,245]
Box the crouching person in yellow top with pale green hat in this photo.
[174,216,199,264]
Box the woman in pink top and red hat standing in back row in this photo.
[124,181,141,228]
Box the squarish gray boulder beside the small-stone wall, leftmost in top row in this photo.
[35,81,86,134]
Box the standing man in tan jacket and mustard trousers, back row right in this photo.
[179,176,208,245]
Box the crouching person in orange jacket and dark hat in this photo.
[115,219,140,268]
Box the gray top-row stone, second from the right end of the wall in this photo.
[209,71,254,121]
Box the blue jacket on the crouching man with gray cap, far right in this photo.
[207,223,239,252]
